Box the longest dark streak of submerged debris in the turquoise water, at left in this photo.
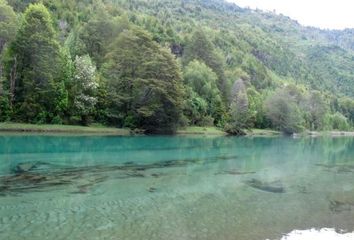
[0,156,236,196]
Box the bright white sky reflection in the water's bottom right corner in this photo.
[282,228,354,240]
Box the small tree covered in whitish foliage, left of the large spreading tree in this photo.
[70,55,98,125]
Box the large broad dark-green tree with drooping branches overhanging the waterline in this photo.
[103,28,183,132]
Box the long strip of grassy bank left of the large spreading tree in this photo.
[0,123,131,136]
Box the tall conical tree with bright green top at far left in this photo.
[5,4,67,123]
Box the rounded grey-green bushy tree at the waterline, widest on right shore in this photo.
[265,90,303,134]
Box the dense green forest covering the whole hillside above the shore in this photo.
[0,0,354,134]
